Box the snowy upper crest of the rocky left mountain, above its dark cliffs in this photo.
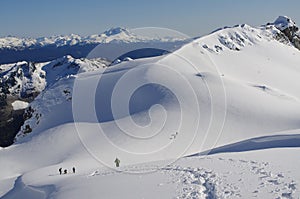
[0,55,109,98]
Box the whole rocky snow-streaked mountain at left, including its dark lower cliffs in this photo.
[0,56,110,146]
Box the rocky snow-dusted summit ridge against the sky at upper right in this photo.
[196,16,300,53]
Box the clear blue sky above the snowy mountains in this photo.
[0,0,300,37]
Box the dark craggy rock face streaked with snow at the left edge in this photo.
[0,62,39,147]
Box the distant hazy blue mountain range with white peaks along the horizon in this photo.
[0,27,188,64]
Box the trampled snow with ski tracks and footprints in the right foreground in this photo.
[87,157,297,199]
